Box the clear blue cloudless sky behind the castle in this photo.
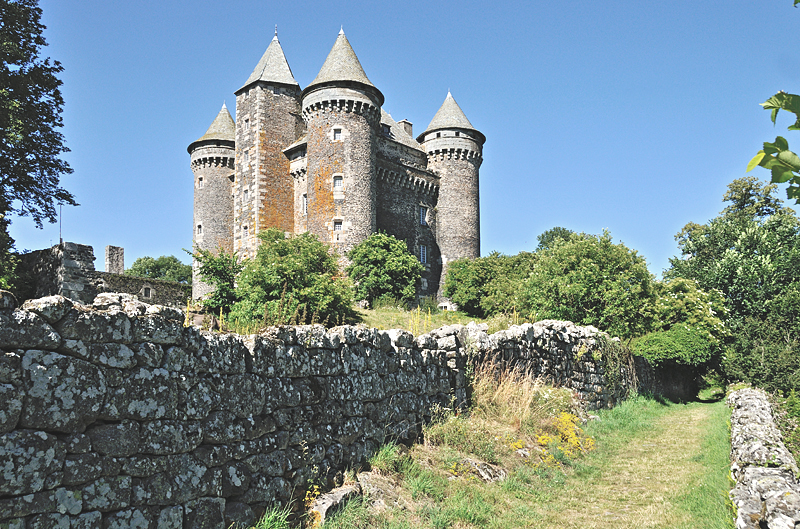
[11,0,800,275]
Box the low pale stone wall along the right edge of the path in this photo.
[728,388,800,529]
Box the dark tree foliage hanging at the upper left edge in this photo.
[0,0,77,228]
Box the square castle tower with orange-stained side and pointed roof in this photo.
[233,29,304,257]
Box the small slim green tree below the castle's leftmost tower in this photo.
[192,247,244,314]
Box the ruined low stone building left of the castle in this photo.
[19,242,191,307]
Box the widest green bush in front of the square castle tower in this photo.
[225,228,353,325]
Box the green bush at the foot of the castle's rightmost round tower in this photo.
[444,252,536,318]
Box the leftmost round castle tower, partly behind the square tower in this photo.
[187,104,236,299]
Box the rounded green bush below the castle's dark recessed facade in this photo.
[345,233,425,305]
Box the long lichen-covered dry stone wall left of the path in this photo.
[0,293,652,529]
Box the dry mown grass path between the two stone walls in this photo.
[534,403,724,529]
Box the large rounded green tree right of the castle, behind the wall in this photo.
[520,232,656,338]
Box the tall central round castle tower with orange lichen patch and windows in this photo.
[303,31,383,254]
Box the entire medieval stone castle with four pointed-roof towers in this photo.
[188,30,486,298]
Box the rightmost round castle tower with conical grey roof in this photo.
[417,91,486,291]
